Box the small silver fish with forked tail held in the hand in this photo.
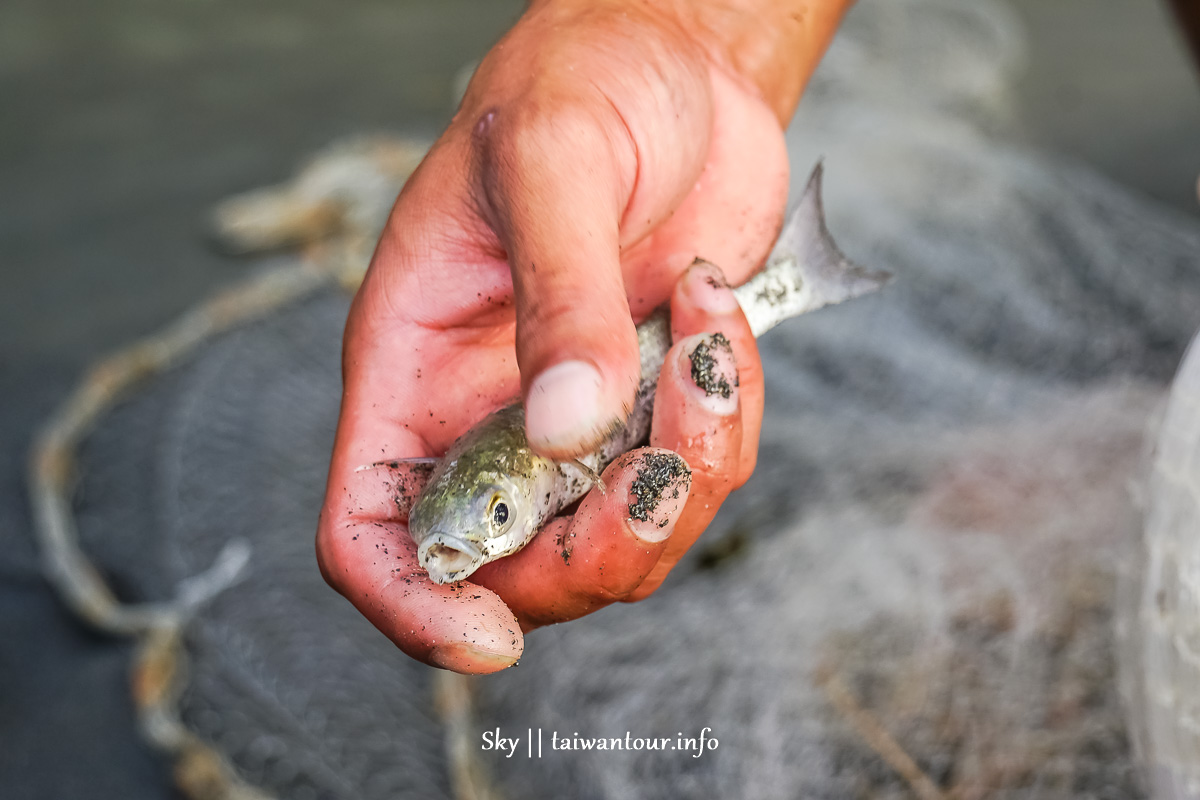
[391,164,889,583]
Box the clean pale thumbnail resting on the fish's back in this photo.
[526,361,601,452]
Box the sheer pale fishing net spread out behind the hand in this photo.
[30,0,1200,800]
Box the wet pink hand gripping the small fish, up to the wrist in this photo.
[317,4,816,673]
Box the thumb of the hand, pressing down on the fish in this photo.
[475,101,641,458]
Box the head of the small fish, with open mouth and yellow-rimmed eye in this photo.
[408,473,535,583]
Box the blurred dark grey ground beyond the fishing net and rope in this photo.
[0,0,1200,798]
